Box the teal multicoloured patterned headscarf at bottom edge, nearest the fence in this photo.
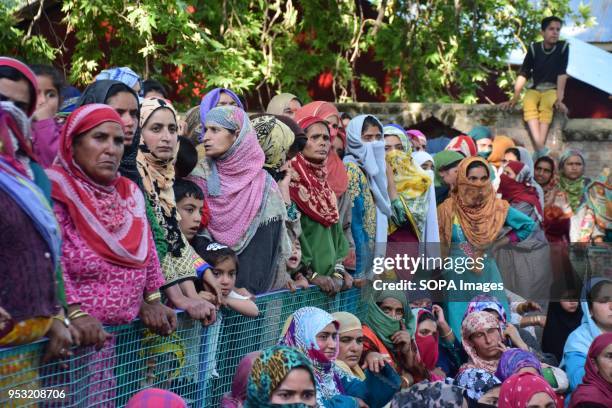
[244,346,315,408]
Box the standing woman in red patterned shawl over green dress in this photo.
[288,113,352,293]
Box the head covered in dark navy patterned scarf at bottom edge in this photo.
[391,381,466,408]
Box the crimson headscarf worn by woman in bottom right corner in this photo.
[570,333,612,408]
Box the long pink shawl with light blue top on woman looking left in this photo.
[204,106,270,246]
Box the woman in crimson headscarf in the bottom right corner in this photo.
[569,333,612,408]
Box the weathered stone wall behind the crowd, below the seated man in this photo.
[337,103,612,176]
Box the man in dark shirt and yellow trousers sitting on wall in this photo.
[502,16,569,151]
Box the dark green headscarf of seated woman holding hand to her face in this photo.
[364,290,415,349]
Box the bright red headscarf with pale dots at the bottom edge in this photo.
[498,373,557,408]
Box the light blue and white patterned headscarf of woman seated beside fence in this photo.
[280,306,343,406]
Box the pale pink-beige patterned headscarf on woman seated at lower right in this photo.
[459,312,503,374]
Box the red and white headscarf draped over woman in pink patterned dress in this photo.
[47,104,150,268]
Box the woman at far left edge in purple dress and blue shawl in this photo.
[0,102,72,364]
